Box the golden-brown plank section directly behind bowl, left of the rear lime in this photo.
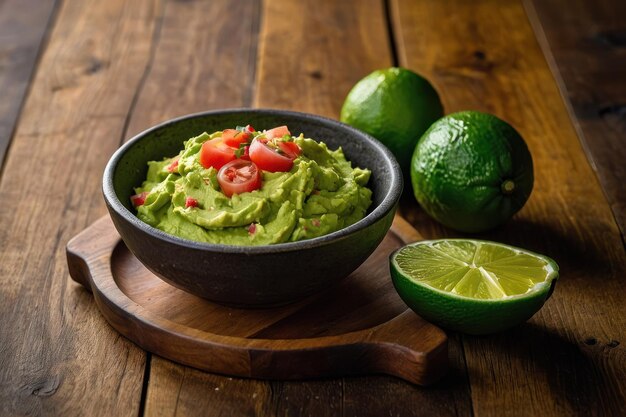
[254,0,392,119]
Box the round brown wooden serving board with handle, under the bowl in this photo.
[67,216,448,385]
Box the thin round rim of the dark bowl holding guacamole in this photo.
[102,108,403,255]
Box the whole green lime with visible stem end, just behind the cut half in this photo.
[411,111,533,232]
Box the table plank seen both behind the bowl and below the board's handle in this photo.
[255,0,471,416]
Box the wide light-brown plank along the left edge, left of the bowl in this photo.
[0,0,159,416]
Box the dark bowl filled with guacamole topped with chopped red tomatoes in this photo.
[103,109,402,308]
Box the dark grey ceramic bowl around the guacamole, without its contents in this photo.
[103,109,402,308]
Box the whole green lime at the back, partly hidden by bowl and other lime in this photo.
[341,68,443,172]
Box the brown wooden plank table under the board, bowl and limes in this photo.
[0,0,626,416]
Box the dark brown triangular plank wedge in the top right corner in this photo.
[525,0,626,243]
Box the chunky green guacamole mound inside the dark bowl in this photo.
[131,126,372,246]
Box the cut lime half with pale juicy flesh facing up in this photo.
[389,239,559,334]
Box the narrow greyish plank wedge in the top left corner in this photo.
[0,0,56,172]
